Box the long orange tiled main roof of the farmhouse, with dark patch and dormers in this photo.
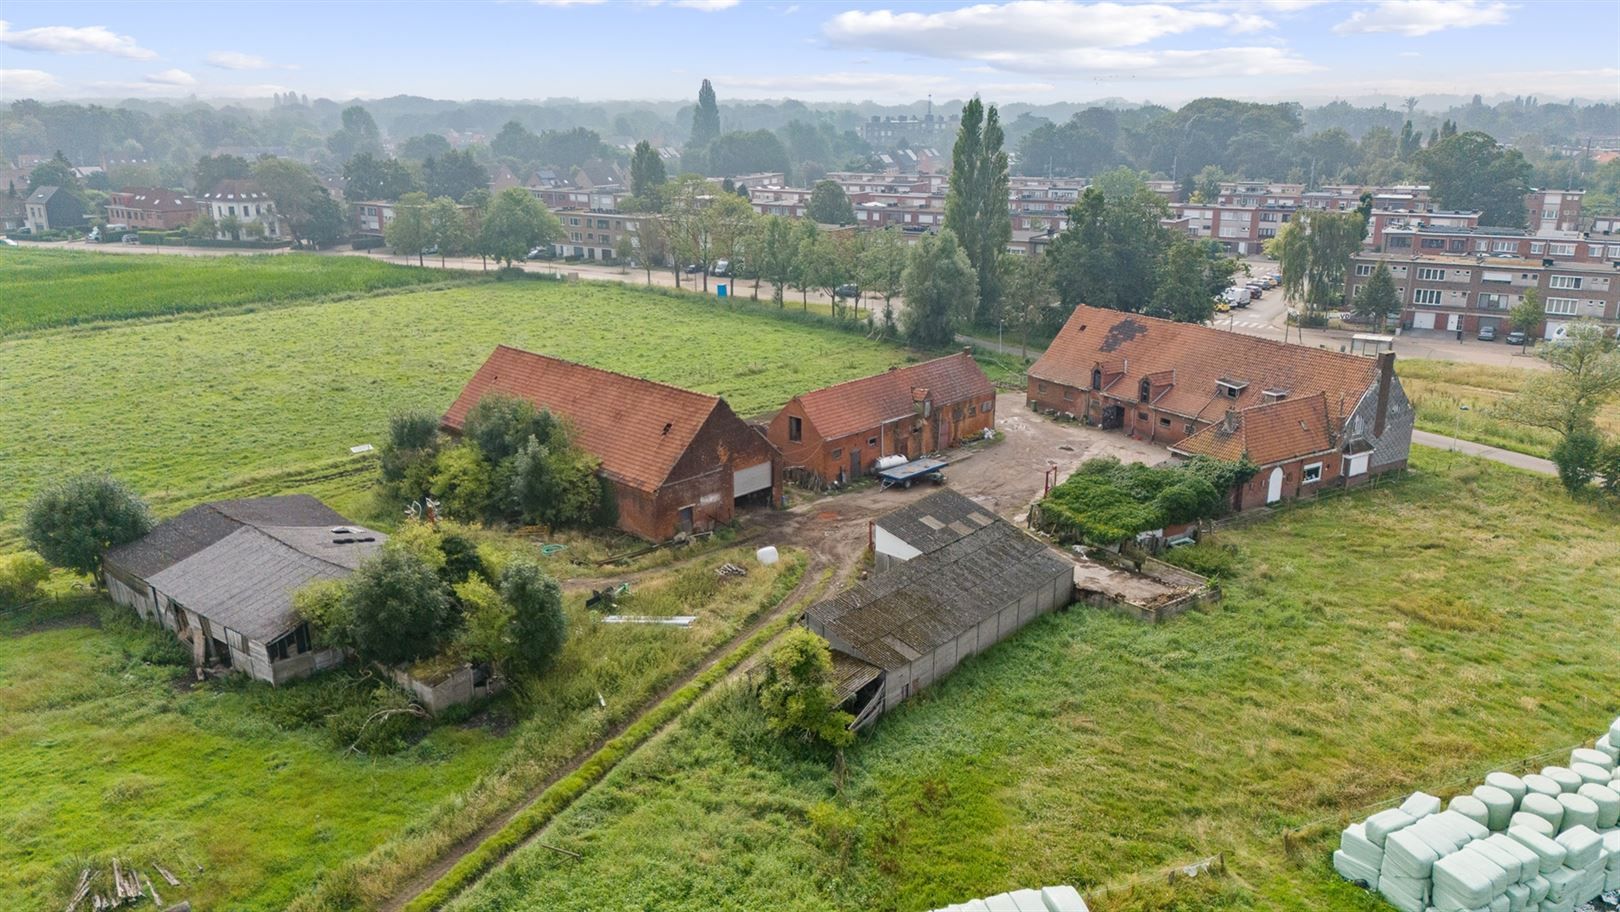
[1029,306,1379,421]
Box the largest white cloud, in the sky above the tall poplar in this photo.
[823,0,1260,60]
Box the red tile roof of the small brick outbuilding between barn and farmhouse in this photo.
[799,352,996,439]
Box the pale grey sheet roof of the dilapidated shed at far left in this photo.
[107,494,387,643]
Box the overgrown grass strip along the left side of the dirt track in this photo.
[290,551,804,912]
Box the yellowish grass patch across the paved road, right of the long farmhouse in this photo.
[1395,358,1620,458]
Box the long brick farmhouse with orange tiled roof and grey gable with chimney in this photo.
[1029,306,1414,510]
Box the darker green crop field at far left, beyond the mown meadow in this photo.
[0,248,471,339]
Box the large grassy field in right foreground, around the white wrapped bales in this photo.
[454,449,1620,912]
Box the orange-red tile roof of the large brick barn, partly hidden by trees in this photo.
[444,345,723,492]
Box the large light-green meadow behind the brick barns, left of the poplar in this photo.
[0,280,907,534]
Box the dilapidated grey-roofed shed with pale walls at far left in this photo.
[102,494,387,684]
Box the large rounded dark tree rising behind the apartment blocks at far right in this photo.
[1416,126,1531,228]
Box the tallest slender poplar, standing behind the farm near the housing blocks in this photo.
[944,96,1013,321]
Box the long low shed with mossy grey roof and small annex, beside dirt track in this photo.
[805,491,1074,727]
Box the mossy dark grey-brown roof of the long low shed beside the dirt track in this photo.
[810,520,1074,671]
